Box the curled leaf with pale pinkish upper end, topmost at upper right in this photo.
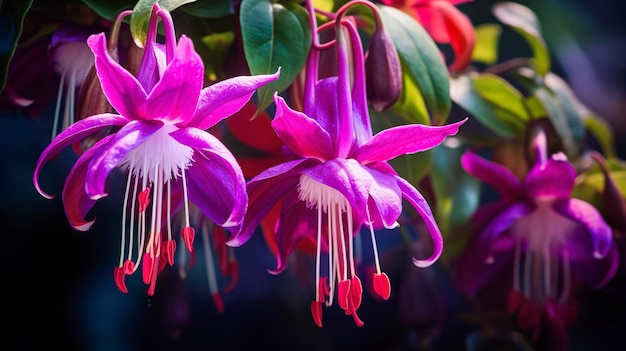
[493,1,551,76]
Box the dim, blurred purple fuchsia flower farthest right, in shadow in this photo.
[456,127,619,347]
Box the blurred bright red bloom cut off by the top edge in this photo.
[382,0,476,71]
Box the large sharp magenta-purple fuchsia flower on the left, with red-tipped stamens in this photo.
[33,4,278,295]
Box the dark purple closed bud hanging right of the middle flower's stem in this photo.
[365,27,402,111]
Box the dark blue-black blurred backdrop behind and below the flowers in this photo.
[0,0,626,351]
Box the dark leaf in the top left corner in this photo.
[0,0,32,92]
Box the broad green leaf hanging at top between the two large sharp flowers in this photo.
[240,0,311,110]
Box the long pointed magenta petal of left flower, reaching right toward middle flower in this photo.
[185,70,280,129]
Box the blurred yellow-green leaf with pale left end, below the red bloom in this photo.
[450,74,527,139]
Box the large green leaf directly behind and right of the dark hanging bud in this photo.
[378,5,452,124]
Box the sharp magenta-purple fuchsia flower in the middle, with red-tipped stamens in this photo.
[228,5,464,327]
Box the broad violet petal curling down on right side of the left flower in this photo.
[170,128,248,228]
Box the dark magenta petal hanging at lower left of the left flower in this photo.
[62,135,113,231]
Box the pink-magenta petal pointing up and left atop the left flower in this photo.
[87,33,147,119]
